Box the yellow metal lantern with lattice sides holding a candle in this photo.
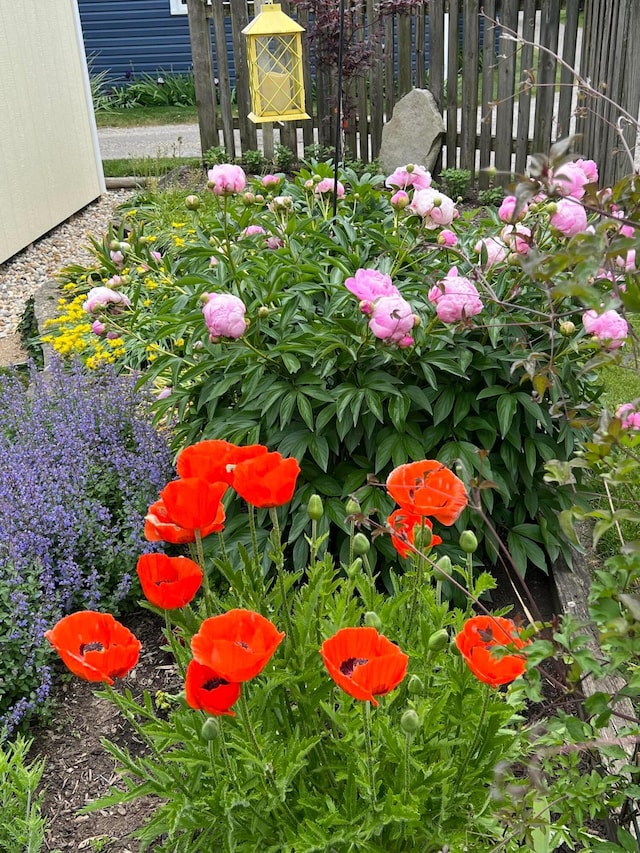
[242,3,309,123]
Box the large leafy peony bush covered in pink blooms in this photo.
[45,148,640,572]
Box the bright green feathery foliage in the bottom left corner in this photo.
[0,736,45,853]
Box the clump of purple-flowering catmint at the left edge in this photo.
[0,361,172,730]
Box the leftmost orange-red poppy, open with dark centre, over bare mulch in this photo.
[45,610,141,684]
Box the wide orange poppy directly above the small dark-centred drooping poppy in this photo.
[191,609,284,682]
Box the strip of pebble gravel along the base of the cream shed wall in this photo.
[0,190,131,338]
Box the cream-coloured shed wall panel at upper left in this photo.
[0,0,104,263]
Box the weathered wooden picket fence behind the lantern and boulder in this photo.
[211,0,638,186]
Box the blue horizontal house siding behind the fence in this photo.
[78,0,235,83]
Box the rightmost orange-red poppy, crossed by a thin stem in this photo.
[456,616,529,687]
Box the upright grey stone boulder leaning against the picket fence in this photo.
[378,89,446,174]
